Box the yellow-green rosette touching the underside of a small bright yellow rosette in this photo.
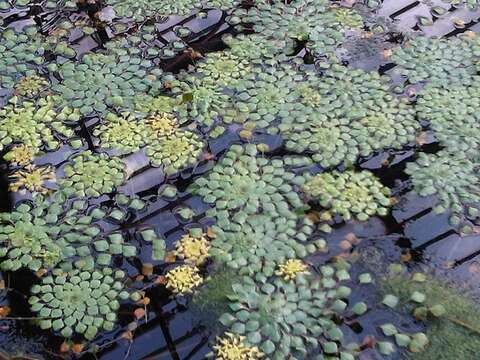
[145,130,204,174]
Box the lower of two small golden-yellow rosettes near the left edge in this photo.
[10,165,55,194]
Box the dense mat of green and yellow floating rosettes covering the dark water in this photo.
[0,0,480,360]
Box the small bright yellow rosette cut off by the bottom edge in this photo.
[213,332,264,360]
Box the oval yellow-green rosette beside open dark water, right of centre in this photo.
[303,170,393,225]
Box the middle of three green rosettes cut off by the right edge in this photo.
[416,76,480,159]
